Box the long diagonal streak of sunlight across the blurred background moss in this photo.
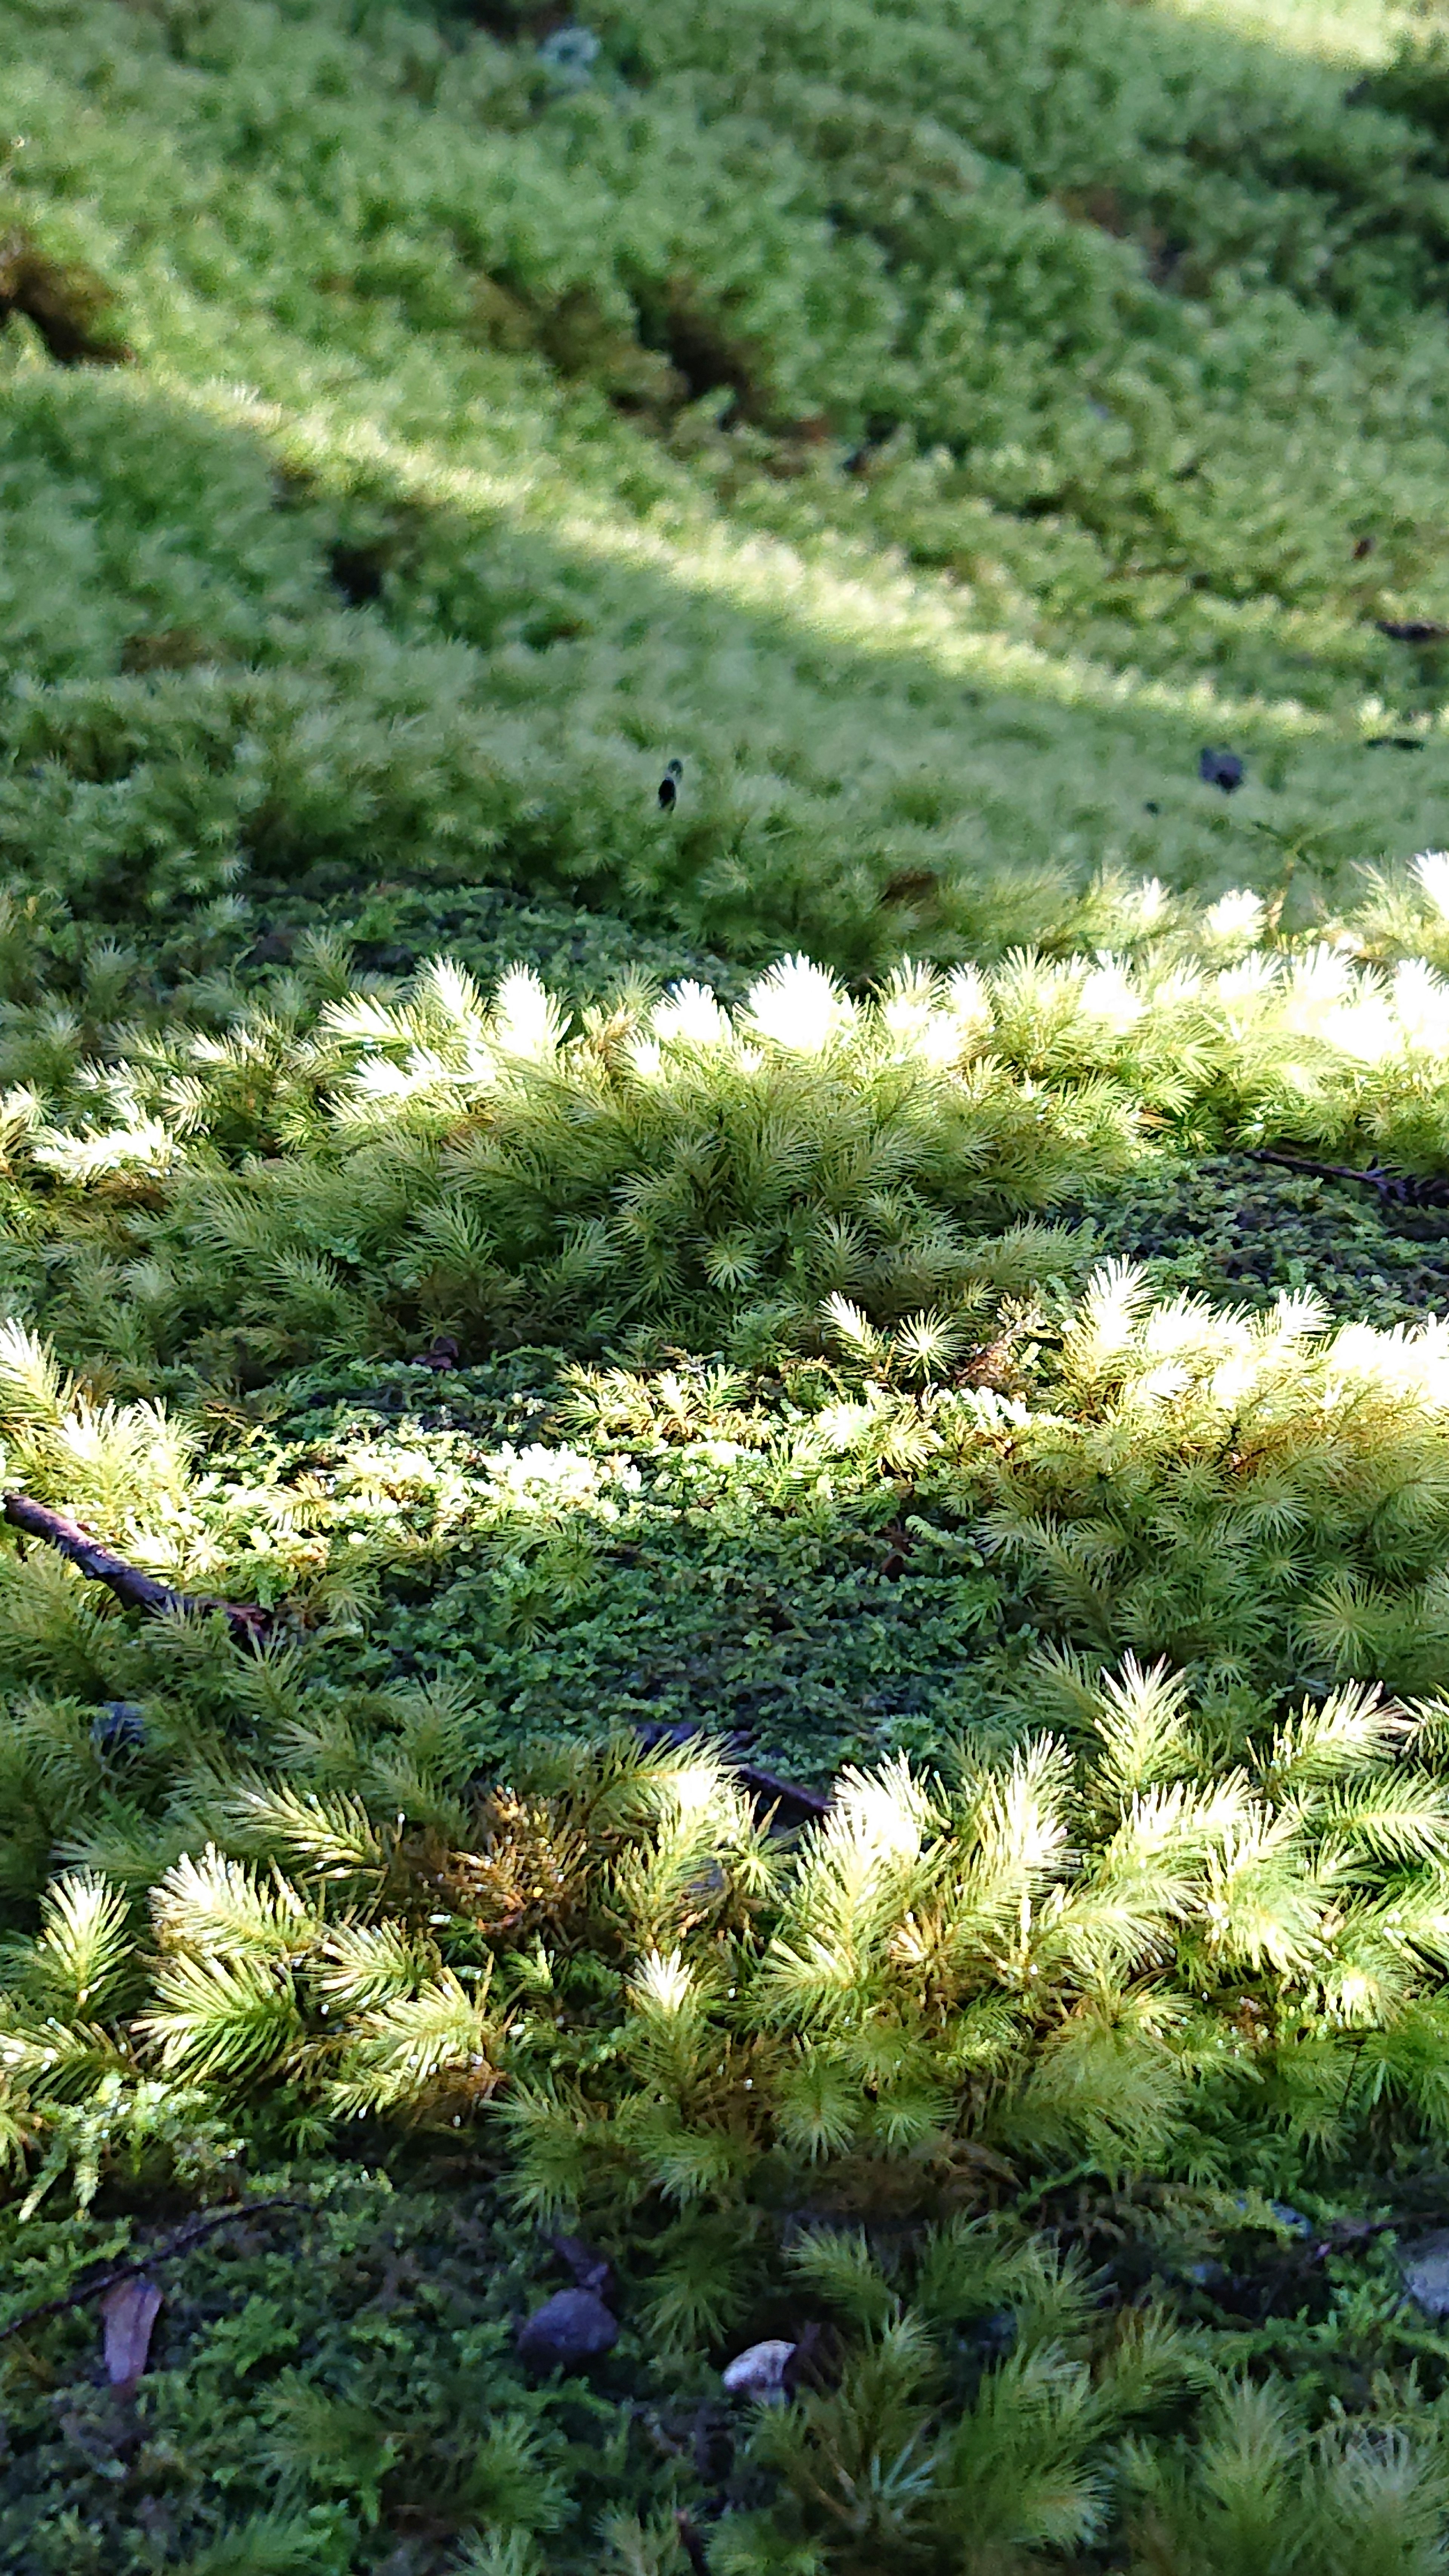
[149,363,1377,742]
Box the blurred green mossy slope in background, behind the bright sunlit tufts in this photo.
[0,0,1444,974]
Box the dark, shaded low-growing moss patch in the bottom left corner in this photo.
[0,2164,699,2576]
